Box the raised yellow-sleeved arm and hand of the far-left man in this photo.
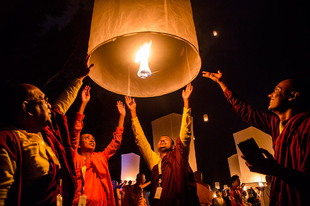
[53,55,94,115]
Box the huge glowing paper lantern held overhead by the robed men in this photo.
[88,0,201,97]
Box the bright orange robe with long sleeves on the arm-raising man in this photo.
[71,113,124,206]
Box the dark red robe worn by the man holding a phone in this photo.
[224,89,310,206]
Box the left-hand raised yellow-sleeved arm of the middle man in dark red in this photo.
[125,96,161,170]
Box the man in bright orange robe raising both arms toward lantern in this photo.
[71,86,126,206]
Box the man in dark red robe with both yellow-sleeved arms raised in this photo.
[125,84,200,206]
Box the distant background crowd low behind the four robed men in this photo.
[112,171,272,206]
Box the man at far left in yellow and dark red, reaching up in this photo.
[0,55,93,206]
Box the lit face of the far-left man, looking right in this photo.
[27,86,52,127]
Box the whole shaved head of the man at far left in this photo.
[1,84,51,132]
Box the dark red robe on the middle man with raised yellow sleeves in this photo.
[151,137,200,206]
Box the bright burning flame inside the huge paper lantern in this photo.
[135,41,152,79]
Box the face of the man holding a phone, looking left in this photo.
[268,80,292,112]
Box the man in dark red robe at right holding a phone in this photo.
[203,71,310,206]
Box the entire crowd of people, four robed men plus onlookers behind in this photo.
[0,56,310,206]
